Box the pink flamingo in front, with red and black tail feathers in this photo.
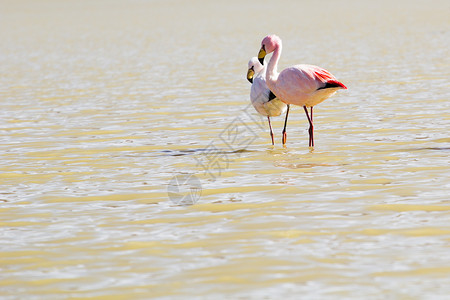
[258,35,347,147]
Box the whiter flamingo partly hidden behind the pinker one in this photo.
[247,57,286,145]
